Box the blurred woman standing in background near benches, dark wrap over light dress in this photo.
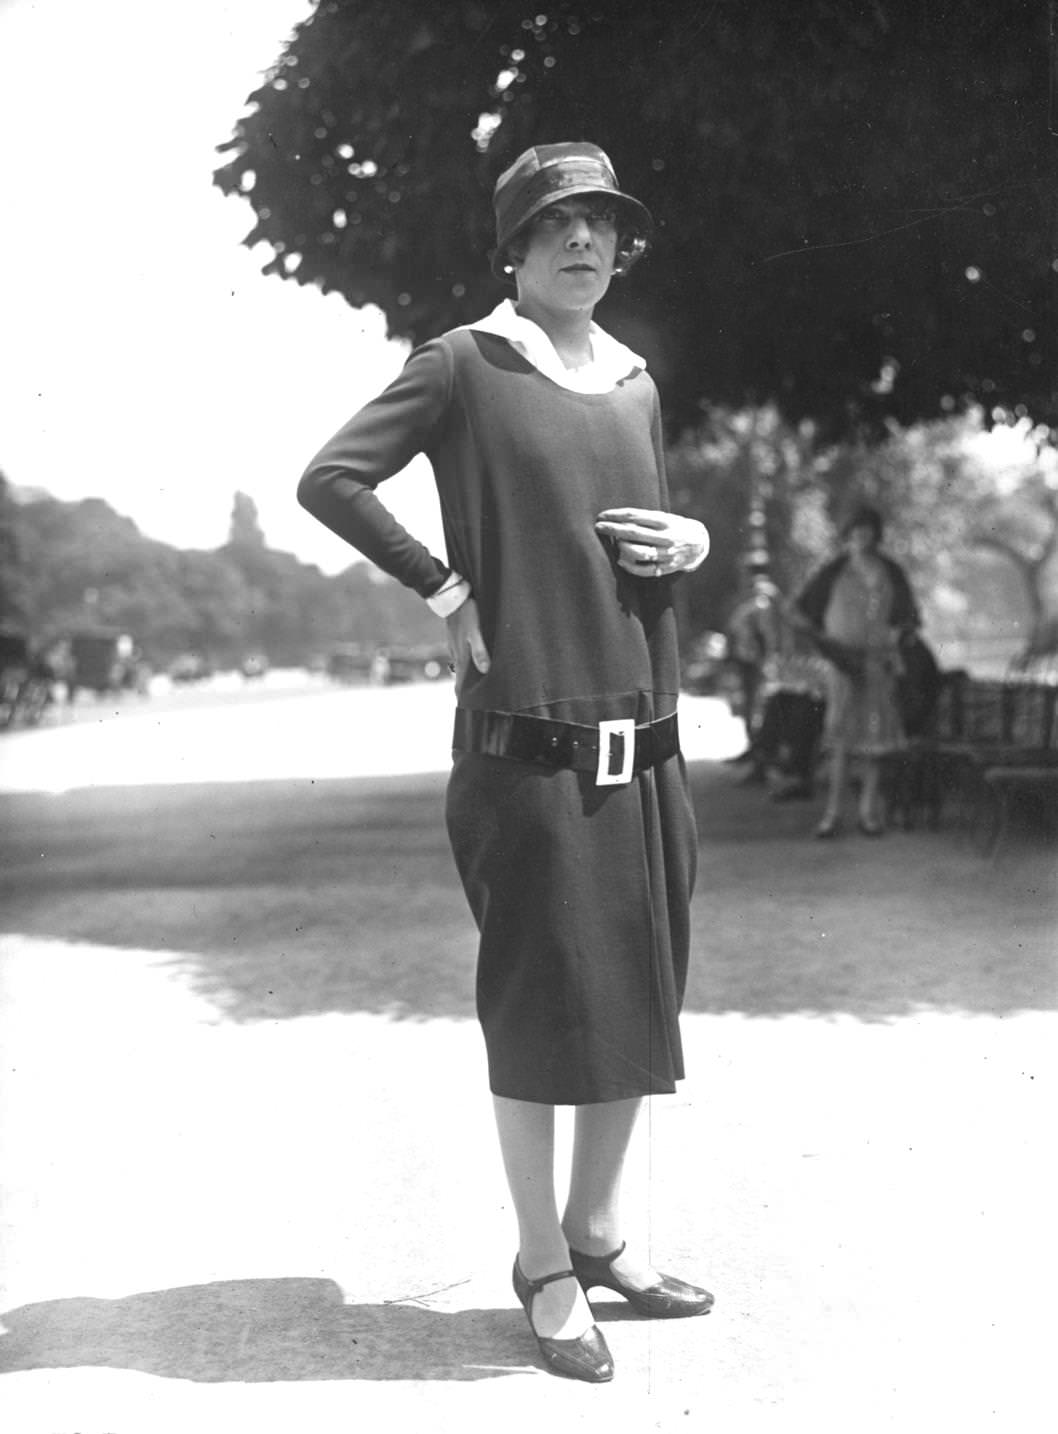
[797,505,919,837]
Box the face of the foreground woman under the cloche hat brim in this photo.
[515,195,616,313]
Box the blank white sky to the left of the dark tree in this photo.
[0,0,443,572]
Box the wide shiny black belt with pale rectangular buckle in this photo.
[452,707,680,787]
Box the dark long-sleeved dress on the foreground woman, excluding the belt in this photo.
[298,308,697,1104]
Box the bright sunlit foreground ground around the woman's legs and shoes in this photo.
[0,685,1058,1434]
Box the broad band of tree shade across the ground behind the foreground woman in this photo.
[0,763,1058,1021]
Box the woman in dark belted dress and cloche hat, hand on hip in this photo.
[298,143,713,1382]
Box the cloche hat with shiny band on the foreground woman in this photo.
[492,141,654,278]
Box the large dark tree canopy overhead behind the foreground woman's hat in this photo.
[215,0,1058,433]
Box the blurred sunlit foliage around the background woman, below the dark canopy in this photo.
[668,407,1058,655]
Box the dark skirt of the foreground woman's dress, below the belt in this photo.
[446,753,697,1106]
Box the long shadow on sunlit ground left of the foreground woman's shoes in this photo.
[0,1279,532,1384]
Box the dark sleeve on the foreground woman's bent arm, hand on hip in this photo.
[298,340,452,598]
